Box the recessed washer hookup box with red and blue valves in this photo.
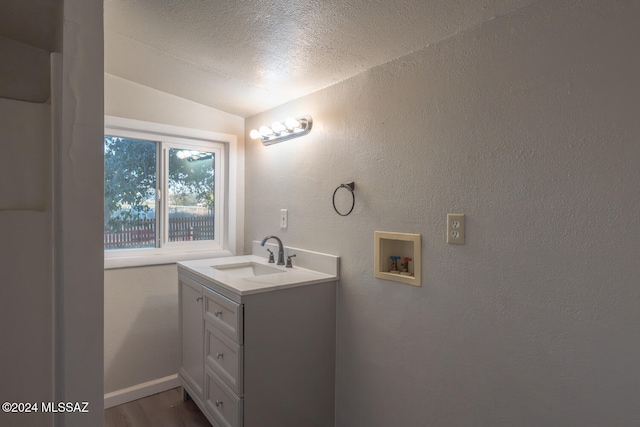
[374,231,422,286]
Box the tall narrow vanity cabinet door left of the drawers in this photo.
[179,280,204,400]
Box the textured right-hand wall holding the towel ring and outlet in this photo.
[245,0,640,427]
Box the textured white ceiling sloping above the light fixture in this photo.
[104,0,540,117]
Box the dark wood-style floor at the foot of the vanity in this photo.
[104,387,211,427]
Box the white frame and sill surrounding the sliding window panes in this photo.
[104,116,237,269]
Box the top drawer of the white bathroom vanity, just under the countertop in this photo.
[204,288,243,345]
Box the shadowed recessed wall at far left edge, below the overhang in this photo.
[0,98,53,426]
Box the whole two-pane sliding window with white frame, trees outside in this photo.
[104,118,240,266]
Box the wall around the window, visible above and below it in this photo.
[104,74,244,399]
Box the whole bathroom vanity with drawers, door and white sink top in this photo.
[178,245,339,427]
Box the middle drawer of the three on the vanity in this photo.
[205,322,244,396]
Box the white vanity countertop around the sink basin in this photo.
[178,255,338,296]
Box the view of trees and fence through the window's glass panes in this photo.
[104,135,216,249]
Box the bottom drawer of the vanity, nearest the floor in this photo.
[205,367,243,427]
